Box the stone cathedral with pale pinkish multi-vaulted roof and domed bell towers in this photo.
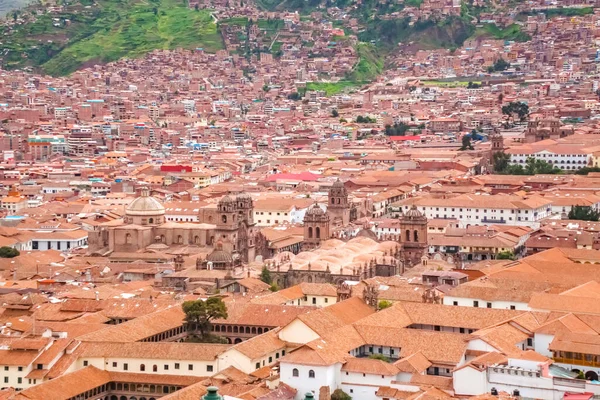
[266,180,427,287]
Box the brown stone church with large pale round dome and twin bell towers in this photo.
[88,188,256,265]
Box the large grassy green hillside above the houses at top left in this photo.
[4,0,223,76]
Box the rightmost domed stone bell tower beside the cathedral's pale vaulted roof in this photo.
[400,204,427,268]
